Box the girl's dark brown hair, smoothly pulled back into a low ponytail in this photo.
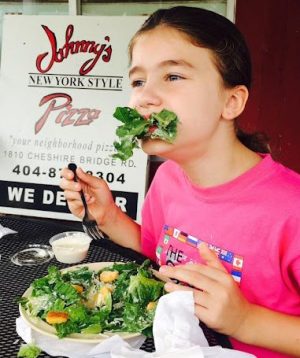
[129,6,269,153]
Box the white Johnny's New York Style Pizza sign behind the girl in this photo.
[0,15,147,221]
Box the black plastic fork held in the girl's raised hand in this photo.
[68,163,104,240]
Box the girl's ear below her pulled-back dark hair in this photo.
[222,85,249,120]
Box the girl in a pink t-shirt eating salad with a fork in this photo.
[61,7,300,358]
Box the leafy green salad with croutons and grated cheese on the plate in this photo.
[19,260,165,338]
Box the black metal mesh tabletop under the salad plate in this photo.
[0,215,231,358]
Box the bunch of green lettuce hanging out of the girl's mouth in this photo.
[113,107,178,160]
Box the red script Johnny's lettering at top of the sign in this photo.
[36,25,112,76]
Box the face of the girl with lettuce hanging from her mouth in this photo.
[129,26,232,162]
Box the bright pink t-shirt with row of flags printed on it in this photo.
[142,155,300,358]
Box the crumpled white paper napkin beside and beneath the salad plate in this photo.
[16,291,254,358]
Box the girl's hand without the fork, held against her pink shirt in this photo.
[159,243,251,337]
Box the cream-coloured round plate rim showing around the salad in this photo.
[19,262,142,343]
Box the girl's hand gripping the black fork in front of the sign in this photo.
[60,168,118,226]
